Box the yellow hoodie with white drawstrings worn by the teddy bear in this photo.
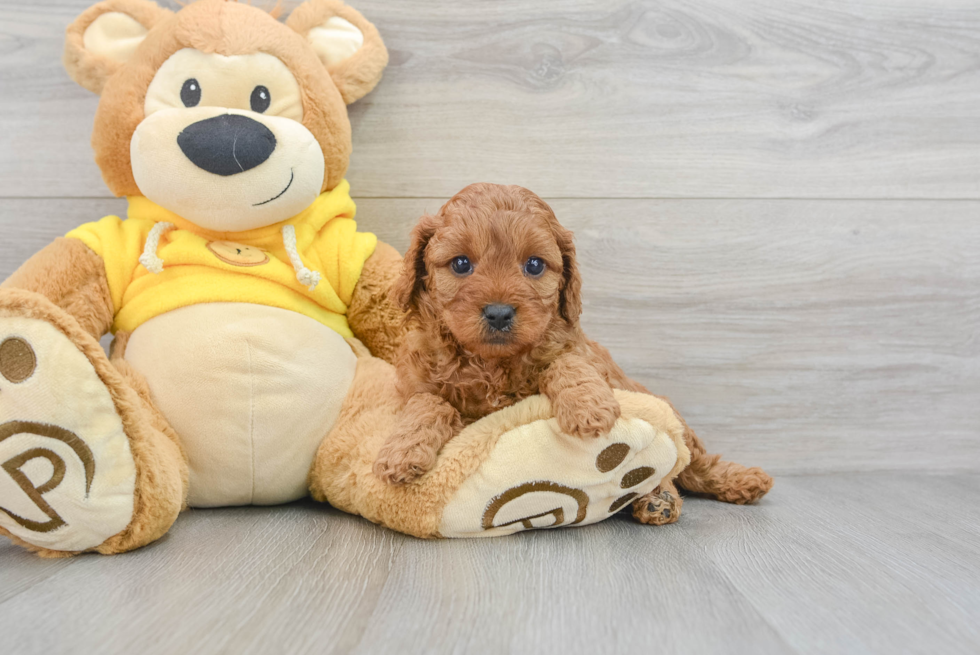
[66,180,378,337]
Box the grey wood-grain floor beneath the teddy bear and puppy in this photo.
[0,473,980,655]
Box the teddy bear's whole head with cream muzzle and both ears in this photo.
[64,0,388,232]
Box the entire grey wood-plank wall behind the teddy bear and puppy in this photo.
[0,0,980,474]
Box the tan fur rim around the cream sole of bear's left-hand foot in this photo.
[0,288,188,557]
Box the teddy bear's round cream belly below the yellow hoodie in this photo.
[125,303,356,507]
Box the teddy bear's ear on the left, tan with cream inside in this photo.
[63,0,173,93]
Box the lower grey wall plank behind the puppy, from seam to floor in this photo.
[0,199,980,473]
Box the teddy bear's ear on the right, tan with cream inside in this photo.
[286,0,388,105]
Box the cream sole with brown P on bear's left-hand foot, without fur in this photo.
[0,312,136,551]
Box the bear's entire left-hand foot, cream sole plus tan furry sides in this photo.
[0,290,187,557]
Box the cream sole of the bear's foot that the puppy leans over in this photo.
[439,390,687,537]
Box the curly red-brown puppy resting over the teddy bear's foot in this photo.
[374,184,772,524]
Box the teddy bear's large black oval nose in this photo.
[177,114,276,175]
